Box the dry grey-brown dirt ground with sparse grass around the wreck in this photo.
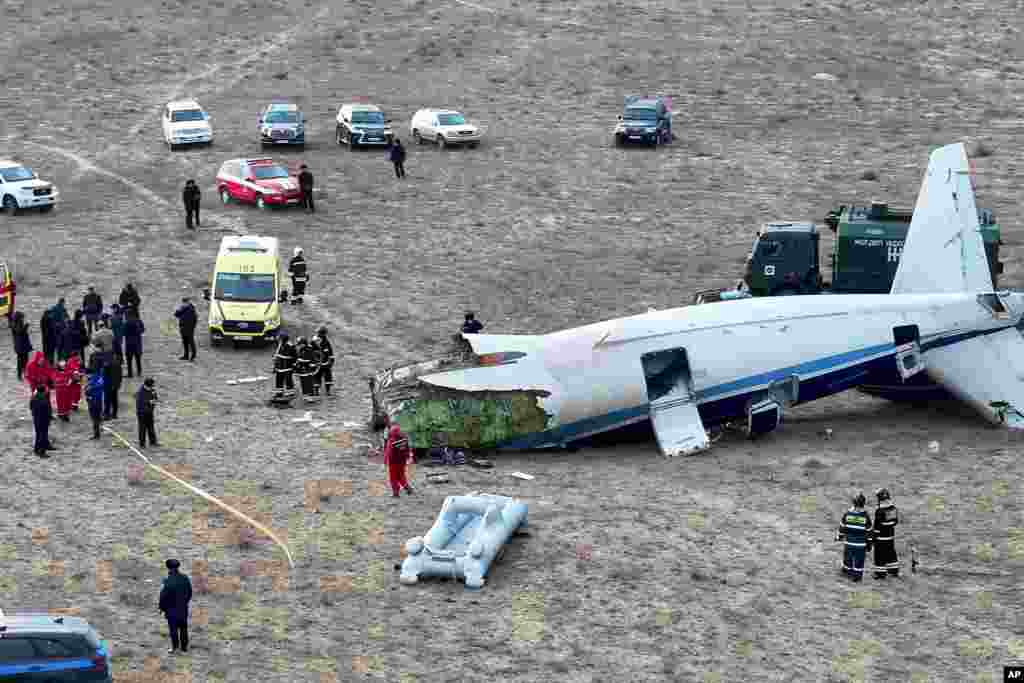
[0,0,1024,683]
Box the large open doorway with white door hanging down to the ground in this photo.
[640,348,711,457]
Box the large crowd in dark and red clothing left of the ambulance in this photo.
[11,283,159,458]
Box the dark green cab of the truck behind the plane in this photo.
[743,222,821,296]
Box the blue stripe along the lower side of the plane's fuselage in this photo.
[497,325,1015,449]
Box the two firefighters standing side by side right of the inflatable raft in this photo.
[836,488,899,582]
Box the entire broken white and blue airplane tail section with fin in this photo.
[370,144,1024,456]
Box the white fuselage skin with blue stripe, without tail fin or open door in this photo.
[434,293,1024,447]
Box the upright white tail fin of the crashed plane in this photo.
[891,142,992,294]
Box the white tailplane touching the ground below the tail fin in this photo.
[927,328,1024,429]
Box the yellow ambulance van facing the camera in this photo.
[210,236,283,346]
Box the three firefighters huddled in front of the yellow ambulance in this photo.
[271,327,334,405]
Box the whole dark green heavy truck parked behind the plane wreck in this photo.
[743,202,1002,296]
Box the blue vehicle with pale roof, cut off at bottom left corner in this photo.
[0,612,114,683]
